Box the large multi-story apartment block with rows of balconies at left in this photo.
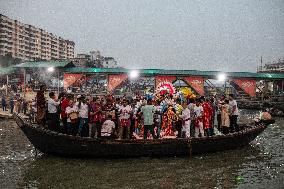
[0,14,75,60]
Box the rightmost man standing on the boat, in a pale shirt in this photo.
[229,94,239,132]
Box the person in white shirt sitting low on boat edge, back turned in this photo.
[101,114,117,139]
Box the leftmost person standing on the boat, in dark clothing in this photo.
[36,85,46,126]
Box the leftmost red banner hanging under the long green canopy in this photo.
[63,74,85,89]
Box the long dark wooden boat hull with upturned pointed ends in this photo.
[13,115,274,158]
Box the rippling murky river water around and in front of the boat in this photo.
[0,111,284,189]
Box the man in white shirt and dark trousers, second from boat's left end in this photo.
[47,92,60,131]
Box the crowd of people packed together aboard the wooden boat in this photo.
[32,85,243,139]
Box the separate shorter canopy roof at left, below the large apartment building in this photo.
[15,60,75,68]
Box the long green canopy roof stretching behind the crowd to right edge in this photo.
[64,67,284,79]
